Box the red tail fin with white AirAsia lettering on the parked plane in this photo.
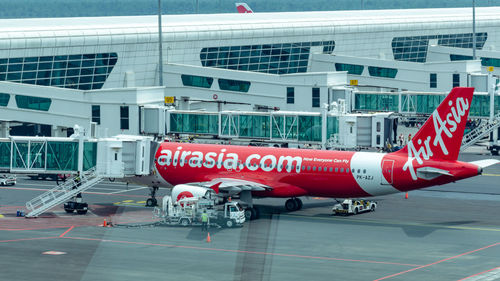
[394,87,474,162]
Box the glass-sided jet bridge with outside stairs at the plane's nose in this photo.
[0,135,157,217]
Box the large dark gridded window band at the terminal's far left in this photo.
[0,53,118,90]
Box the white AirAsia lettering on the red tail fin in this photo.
[403,97,469,180]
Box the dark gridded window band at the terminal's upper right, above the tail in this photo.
[392,32,488,62]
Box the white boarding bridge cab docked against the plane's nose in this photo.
[96,135,154,178]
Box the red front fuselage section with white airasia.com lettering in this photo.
[156,142,370,197]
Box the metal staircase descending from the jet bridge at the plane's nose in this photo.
[26,168,103,218]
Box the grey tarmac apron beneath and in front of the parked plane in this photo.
[0,150,500,281]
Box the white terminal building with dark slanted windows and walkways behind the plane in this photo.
[0,7,500,145]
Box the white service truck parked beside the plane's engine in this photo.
[153,196,245,227]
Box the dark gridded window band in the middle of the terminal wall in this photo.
[200,41,335,74]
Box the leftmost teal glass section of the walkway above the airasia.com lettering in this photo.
[170,113,219,135]
